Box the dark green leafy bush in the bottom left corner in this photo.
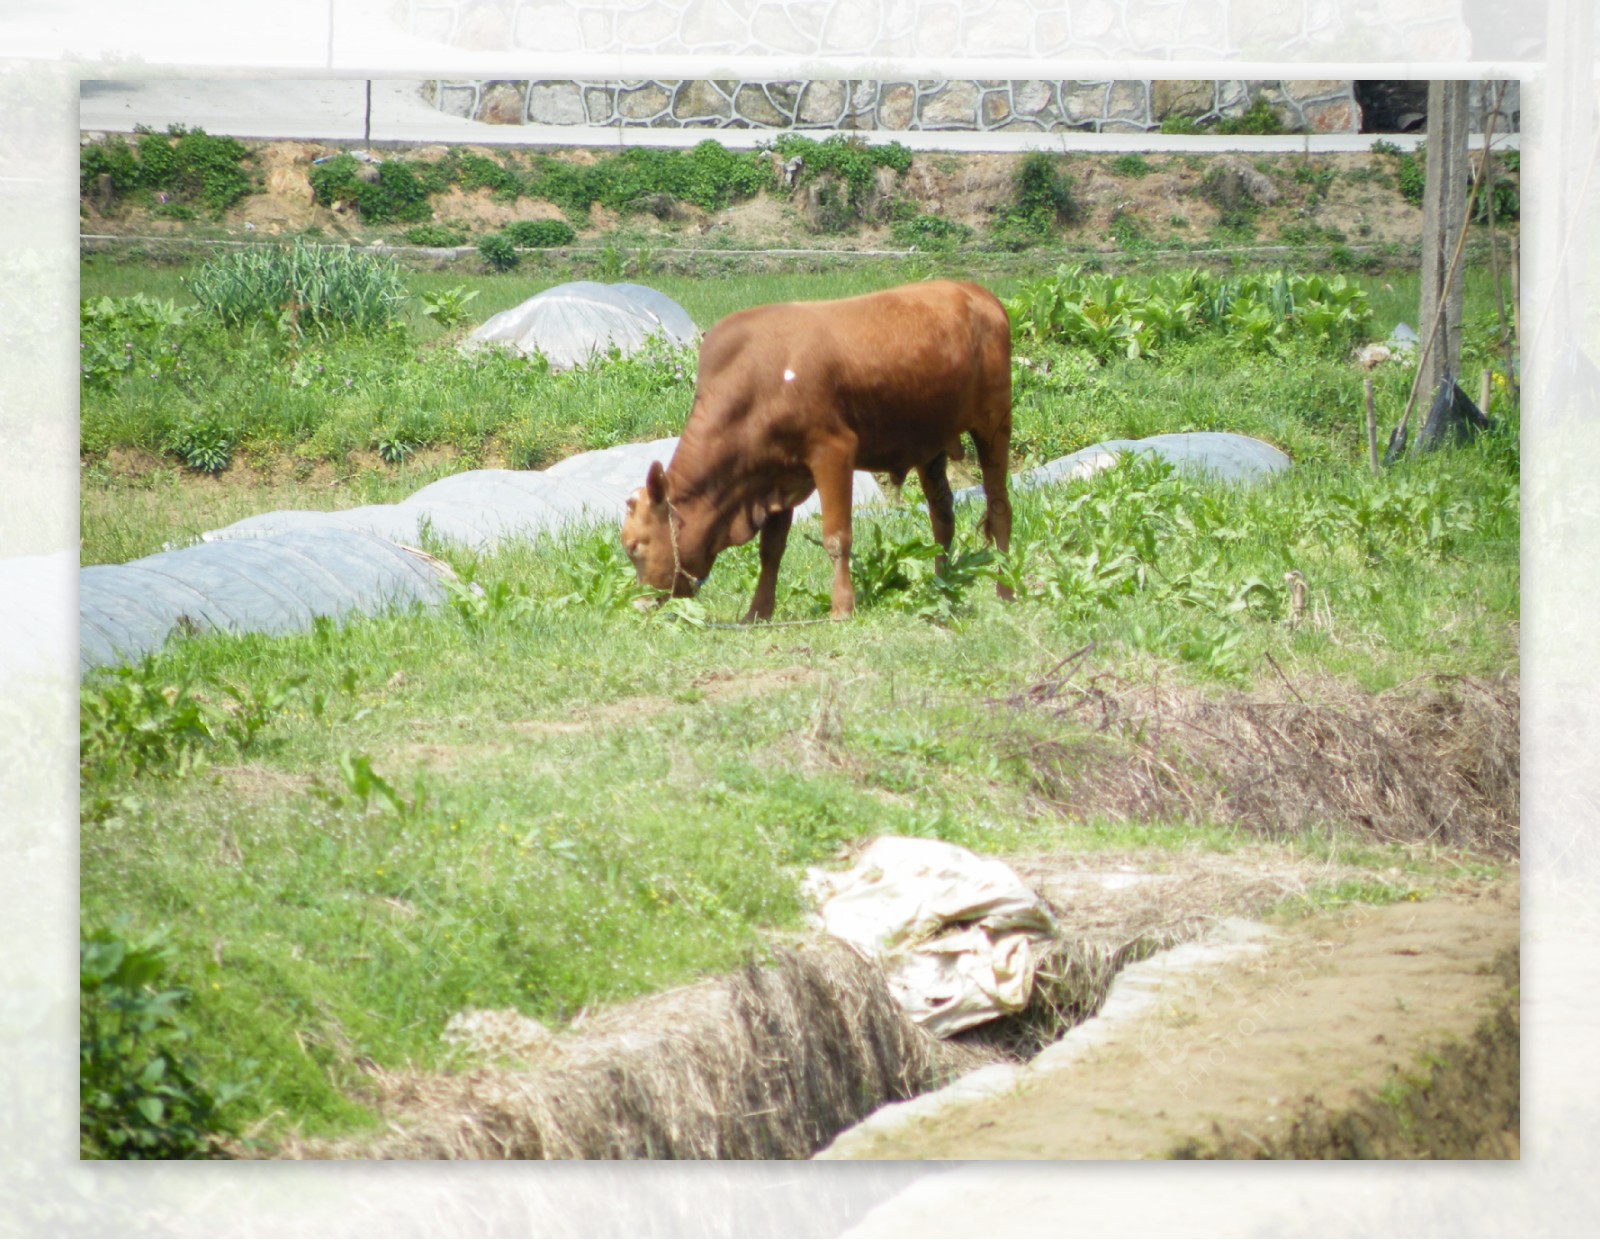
[78,925,250,1158]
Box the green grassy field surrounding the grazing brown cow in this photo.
[80,249,1520,1136]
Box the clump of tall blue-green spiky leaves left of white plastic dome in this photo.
[189,238,406,334]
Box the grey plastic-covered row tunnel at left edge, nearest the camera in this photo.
[78,514,453,672]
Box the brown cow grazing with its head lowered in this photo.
[622,280,1011,621]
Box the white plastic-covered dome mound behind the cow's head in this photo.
[461,280,699,370]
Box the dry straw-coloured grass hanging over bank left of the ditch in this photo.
[278,944,982,1158]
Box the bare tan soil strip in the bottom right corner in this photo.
[832,875,1518,1158]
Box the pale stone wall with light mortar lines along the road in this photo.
[424,78,1520,133]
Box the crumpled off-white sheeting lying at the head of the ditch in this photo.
[806,835,1059,1037]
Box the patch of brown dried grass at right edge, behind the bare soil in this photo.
[1006,661,1522,856]
